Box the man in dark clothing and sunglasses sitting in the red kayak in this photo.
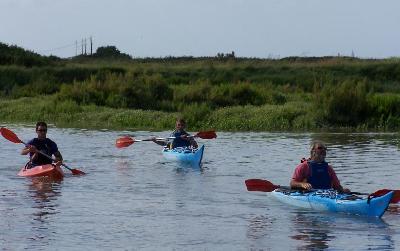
[21,121,63,168]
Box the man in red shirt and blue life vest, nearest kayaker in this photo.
[290,141,350,193]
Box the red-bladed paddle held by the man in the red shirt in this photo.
[245,179,400,203]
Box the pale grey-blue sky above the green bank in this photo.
[0,0,400,58]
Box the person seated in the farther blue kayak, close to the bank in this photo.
[152,118,198,149]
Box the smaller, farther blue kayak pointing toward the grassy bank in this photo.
[162,145,204,166]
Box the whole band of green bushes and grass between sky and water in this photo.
[0,43,400,131]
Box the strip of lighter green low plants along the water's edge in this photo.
[0,96,391,132]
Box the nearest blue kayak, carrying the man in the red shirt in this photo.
[272,188,393,217]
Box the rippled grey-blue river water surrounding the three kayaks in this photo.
[0,125,400,250]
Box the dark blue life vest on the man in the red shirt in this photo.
[307,160,332,189]
